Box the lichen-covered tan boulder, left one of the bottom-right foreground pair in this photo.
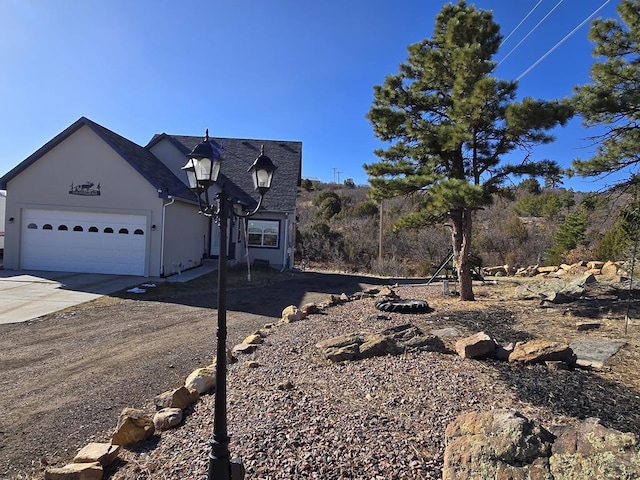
[442,410,554,480]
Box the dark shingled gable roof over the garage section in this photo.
[0,117,197,202]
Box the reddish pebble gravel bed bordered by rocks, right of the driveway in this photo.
[109,287,572,480]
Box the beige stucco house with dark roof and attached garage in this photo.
[0,117,302,276]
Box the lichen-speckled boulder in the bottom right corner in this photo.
[550,418,640,480]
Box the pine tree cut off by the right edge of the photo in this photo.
[573,0,640,188]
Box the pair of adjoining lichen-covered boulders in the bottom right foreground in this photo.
[442,410,640,480]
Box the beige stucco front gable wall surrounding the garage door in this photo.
[4,126,162,276]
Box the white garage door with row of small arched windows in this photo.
[21,209,147,275]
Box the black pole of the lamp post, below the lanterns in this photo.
[207,193,231,480]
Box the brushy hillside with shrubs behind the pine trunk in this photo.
[296,179,631,276]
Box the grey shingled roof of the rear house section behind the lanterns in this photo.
[146,133,302,212]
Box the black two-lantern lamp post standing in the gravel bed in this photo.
[182,129,276,480]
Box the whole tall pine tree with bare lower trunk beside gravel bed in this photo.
[364,1,572,300]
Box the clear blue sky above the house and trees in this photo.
[0,0,618,191]
